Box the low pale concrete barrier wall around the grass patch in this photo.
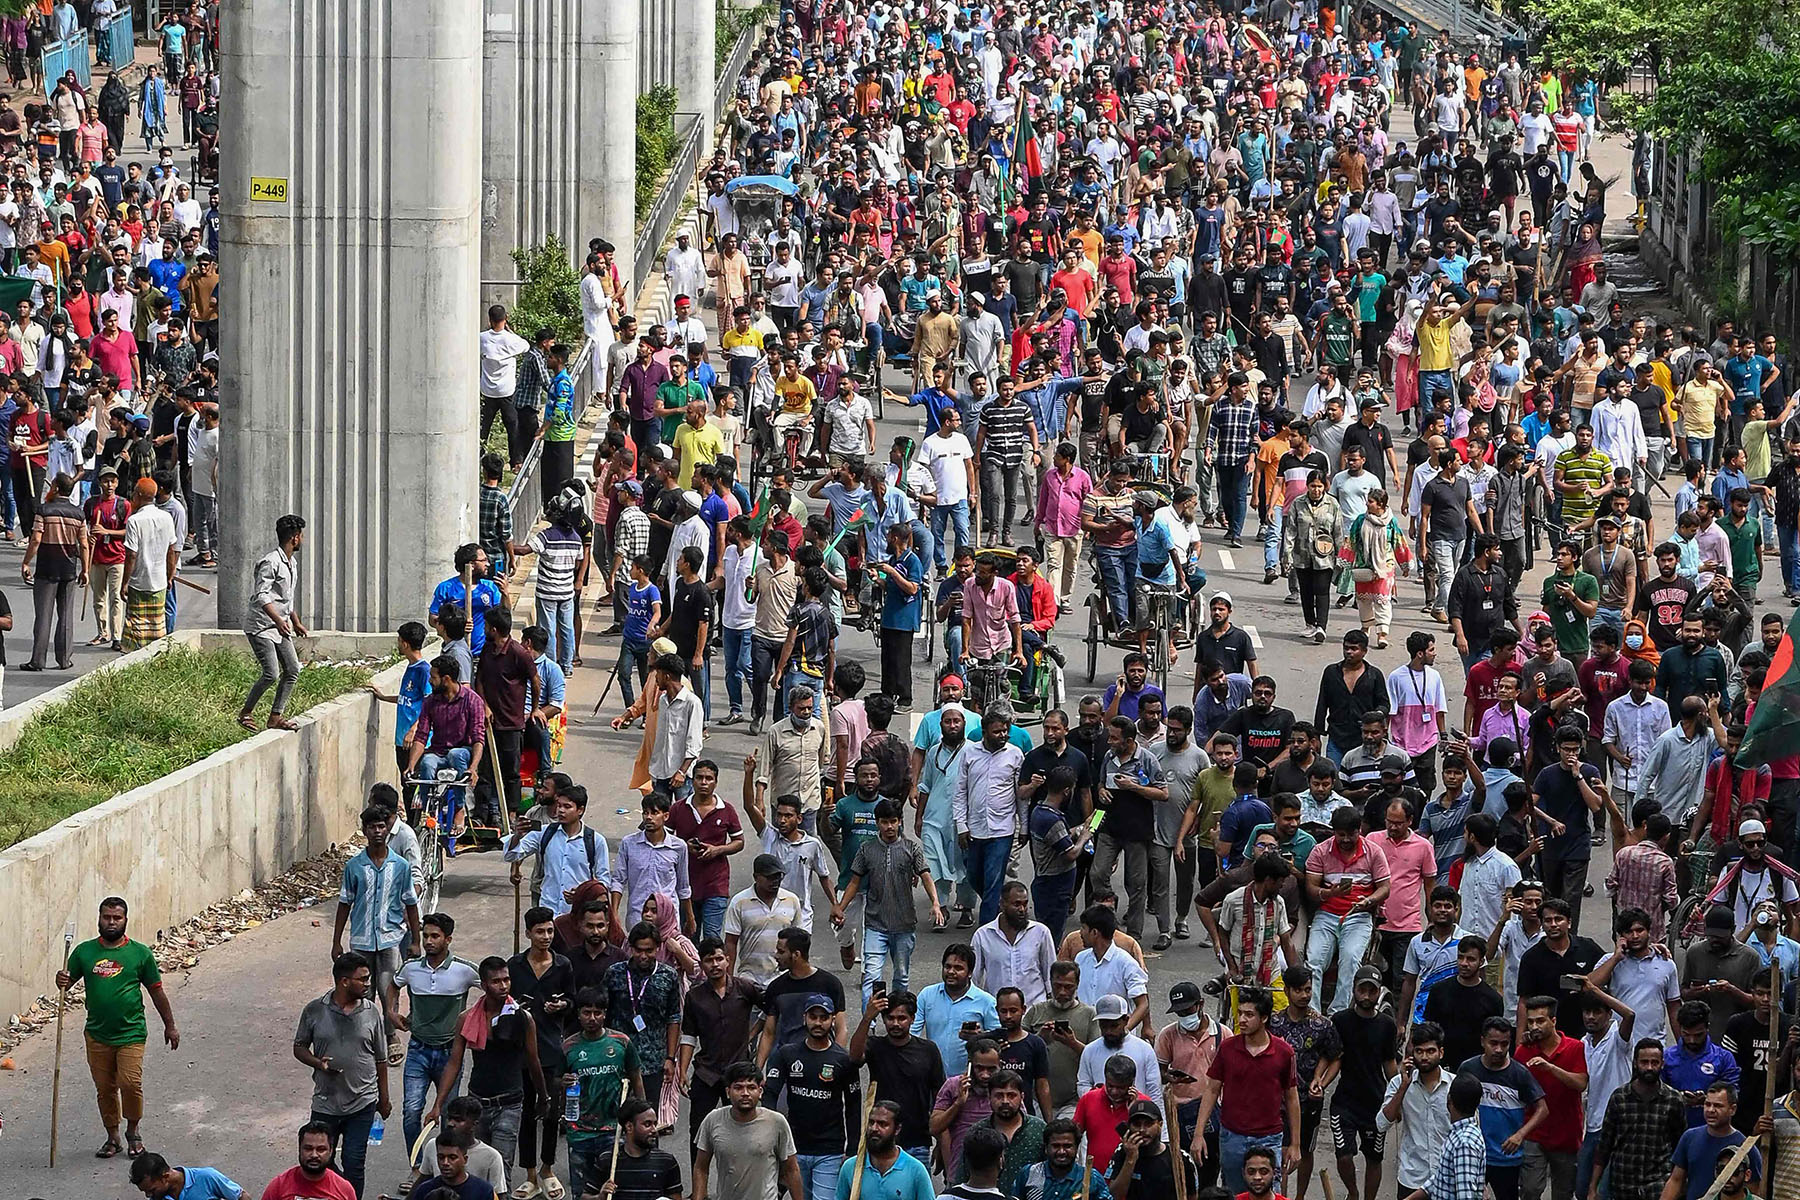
[0,631,403,1015]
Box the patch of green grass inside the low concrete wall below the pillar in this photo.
[0,646,371,847]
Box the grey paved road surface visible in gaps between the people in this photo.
[0,131,1713,1200]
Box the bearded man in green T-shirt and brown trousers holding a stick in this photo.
[52,896,182,1159]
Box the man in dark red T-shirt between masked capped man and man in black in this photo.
[1190,988,1300,1195]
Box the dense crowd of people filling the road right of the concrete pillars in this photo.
[28,0,1800,1200]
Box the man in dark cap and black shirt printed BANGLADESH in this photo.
[763,993,862,1200]
